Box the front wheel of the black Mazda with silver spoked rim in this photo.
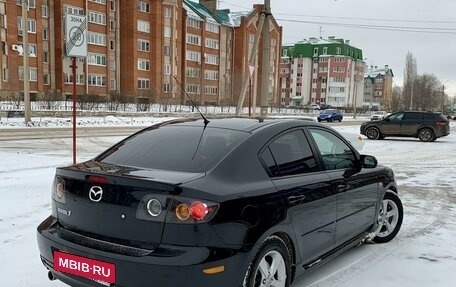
[372,191,404,243]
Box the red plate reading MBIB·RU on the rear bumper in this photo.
[54,251,116,286]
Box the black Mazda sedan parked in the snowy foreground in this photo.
[37,118,403,287]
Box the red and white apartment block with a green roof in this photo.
[279,37,365,107]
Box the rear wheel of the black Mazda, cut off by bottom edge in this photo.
[242,236,291,287]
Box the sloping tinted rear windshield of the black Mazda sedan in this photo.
[95,125,249,172]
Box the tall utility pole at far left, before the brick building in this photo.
[22,0,31,126]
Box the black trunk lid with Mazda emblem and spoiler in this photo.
[53,161,202,248]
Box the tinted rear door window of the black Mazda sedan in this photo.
[261,130,318,177]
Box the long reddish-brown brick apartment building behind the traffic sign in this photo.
[0,0,282,110]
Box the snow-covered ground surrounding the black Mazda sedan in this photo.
[0,119,456,287]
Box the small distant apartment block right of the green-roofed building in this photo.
[363,65,394,111]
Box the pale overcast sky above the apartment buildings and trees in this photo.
[219,0,456,97]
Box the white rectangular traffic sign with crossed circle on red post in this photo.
[65,14,87,58]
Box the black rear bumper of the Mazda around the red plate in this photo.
[37,217,252,287]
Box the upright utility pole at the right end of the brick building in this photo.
[260,0,271,119]
